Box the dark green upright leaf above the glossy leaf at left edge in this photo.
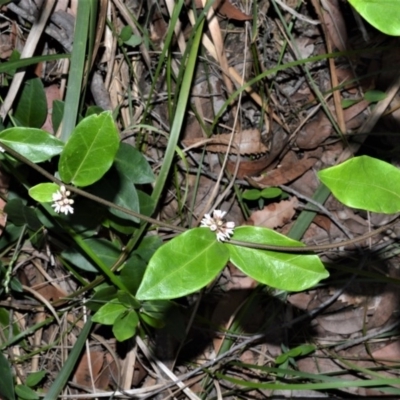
[13,78,47,128]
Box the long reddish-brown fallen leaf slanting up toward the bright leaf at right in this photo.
[247,148,322,188]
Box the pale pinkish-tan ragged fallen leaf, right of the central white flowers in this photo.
[248,197,298,229]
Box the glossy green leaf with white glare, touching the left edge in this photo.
[0,127,64,163]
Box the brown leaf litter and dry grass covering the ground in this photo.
[0,0,400,399]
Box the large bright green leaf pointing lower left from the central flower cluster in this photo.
[136,228,229,300]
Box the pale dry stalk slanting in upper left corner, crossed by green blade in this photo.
[0,0,55,120]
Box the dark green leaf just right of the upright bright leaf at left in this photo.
[114,143,155,184]
